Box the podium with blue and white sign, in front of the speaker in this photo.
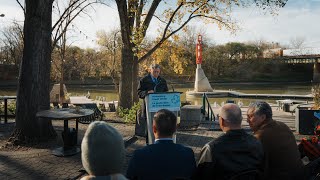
[145,92,181,144]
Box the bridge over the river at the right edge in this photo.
[263,48,320,83]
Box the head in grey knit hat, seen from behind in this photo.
[81,121,125,176]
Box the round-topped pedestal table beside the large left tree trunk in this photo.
[36,108,93,156]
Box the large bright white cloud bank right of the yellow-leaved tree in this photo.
[207,1,320,46]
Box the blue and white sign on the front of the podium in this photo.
[148,93,180,112]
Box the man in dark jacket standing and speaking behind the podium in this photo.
[136,64,168,142]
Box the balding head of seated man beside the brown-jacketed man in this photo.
[219,103,242,132]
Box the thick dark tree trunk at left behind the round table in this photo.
[11,0,56,143]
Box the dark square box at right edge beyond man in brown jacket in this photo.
[295,108,320,135]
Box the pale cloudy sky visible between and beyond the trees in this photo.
[0,0,320,48]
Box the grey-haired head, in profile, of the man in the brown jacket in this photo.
[247,101,272,132]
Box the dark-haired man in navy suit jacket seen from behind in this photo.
[127,109,196,180]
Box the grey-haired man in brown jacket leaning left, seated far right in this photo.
[247,101,305,180]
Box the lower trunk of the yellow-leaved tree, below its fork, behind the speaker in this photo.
[119,45,134,108]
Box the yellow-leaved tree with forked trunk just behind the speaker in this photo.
[115,0,287,108]
